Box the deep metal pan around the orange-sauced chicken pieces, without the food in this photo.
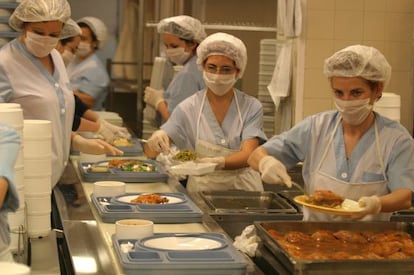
[254,221,414,274]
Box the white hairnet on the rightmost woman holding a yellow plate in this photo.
[323,45,391,87]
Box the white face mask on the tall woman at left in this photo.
[24,31,59,57]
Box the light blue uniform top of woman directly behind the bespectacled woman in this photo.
[164,56,206,114]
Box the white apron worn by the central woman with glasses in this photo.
[187,92,263,193]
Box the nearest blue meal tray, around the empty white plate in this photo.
[112,233,247,275]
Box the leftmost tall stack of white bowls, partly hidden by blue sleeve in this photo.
[0,103,27,253]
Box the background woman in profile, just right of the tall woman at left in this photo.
[67,16,109,111]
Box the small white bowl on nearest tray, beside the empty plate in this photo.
[115,219,154,242]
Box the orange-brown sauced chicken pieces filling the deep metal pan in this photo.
[267,229,414,260]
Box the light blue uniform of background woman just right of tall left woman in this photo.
[68,54,109,111]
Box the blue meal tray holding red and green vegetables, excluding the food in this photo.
[78,159,168,183]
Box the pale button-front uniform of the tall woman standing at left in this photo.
[0,39,75,186]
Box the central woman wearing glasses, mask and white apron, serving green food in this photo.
[145,33,266,192]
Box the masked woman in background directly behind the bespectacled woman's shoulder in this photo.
[144,15,206,122]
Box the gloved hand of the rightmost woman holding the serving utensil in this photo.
[259,156,292,188]
